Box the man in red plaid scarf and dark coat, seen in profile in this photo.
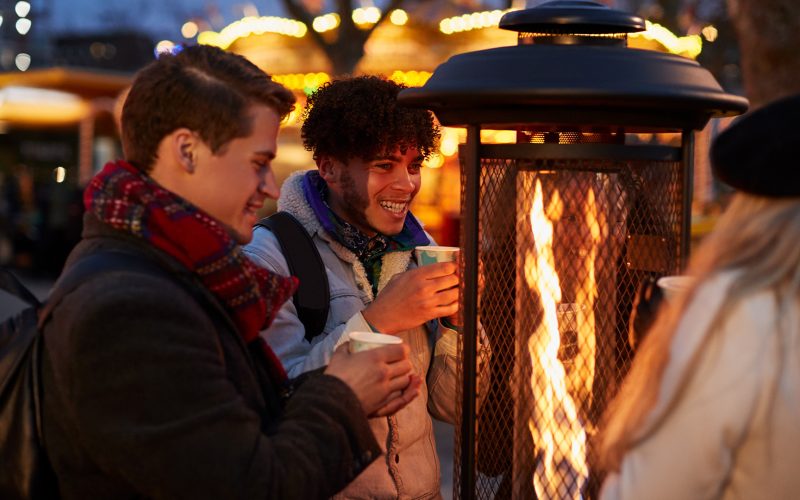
[42,46,419,499]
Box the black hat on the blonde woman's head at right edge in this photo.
[711,94,800,198]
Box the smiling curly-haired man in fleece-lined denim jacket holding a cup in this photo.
[245,76,458,498]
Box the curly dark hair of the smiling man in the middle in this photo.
[301,76,441,162]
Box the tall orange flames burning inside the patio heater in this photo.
[525,180,601,499]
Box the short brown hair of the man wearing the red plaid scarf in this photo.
[121,45,295,172]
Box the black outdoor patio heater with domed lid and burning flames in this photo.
[400,0,748,500]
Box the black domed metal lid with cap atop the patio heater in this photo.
[399,0,748,130]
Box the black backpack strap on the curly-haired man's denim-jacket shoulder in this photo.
[256,212,331,342]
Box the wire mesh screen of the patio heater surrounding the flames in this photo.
[454,154,688,499]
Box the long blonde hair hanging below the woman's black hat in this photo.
[598,193,800,470]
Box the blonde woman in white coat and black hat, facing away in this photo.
[600,95,800,500]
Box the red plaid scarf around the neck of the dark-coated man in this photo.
[83,161,298,380]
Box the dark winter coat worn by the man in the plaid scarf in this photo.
[42,215,381,499]
